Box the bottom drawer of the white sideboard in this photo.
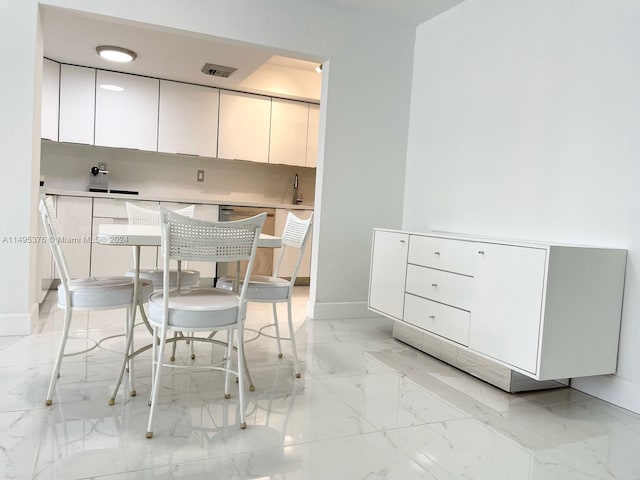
[404,293,469,346]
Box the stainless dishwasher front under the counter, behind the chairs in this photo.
[216,205,276,277]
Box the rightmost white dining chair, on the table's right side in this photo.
[216,212,313,378]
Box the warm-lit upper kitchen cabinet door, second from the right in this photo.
[269,98,309,167]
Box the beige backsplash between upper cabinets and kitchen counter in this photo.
[40,140,316,205]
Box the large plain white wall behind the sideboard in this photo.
[403,0,640,412]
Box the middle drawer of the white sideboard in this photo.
[406,265,473,311]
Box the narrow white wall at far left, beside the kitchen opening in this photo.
[0,0,42,335]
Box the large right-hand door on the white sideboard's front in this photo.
[469,243,546,373]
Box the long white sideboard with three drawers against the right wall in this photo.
[369,229,627,391]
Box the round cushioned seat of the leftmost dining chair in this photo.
[58,277,153,308]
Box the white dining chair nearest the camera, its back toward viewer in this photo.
[146,207,266,438]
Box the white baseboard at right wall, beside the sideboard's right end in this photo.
[571,375,640,414]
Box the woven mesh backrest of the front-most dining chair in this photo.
[160,206,267,299]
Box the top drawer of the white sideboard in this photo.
[408,235,478,276]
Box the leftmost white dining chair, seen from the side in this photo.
[39,196,152,405]
